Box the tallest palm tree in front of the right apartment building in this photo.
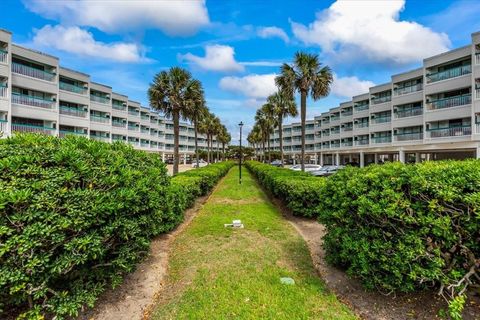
[275,52,333,171]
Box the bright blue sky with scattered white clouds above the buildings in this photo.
[0,0,480,144]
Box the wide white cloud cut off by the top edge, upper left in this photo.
[25,0,210,36]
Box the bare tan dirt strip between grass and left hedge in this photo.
[78,190,215,320]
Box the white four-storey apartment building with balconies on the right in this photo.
[262,32,480,166]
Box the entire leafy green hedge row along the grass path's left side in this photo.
[0,135,229,319]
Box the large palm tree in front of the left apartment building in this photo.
[148,67,203,175]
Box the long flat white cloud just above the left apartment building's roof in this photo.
[33,25,148,62]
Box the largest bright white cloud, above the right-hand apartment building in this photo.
[291,0,450,64]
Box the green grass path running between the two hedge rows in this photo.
[152,168,355,320]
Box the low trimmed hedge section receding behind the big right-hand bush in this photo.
[245,161,325,217]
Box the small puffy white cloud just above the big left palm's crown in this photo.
[179,45,244,71]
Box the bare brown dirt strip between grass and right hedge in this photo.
[274,204,480,320]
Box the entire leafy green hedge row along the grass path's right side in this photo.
[247,160,480,315]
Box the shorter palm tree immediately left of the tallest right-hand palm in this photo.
[267,91,298,166]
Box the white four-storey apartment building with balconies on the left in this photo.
[0,30,221,162]
